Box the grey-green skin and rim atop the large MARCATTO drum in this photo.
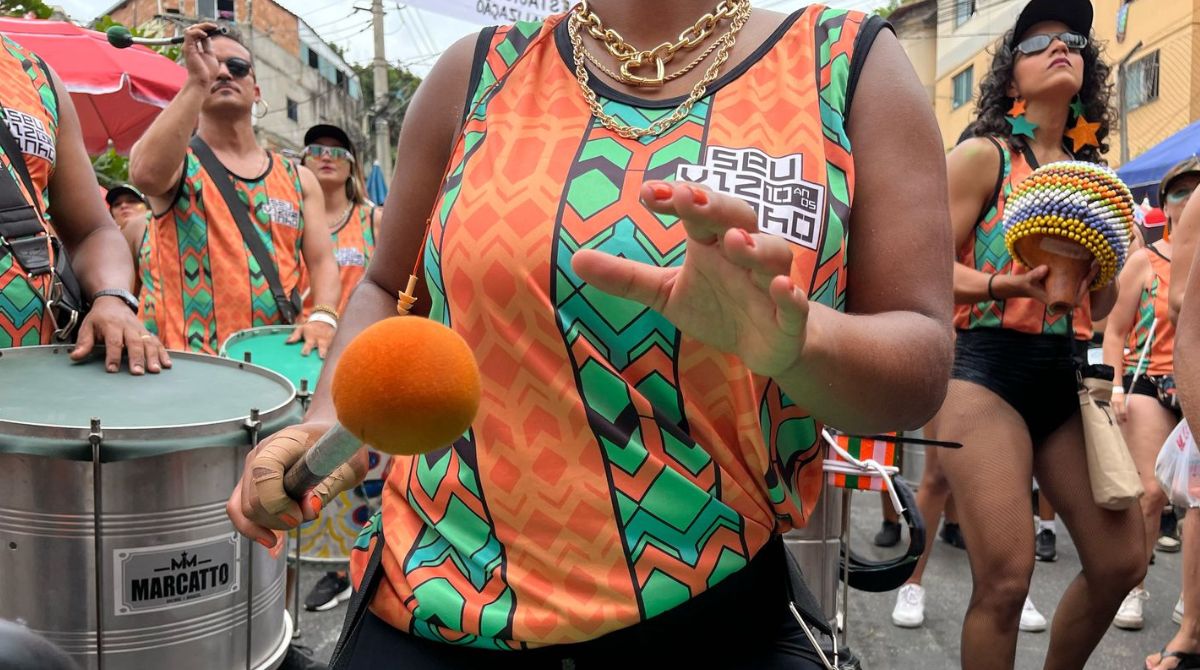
[0,346,299,459]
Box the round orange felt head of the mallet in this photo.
[332,316,480,455]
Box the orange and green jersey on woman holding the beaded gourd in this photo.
[954,138,1092,340]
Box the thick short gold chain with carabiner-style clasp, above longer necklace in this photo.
[576,0,750,86]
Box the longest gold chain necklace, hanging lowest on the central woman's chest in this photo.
[566,0,751,139]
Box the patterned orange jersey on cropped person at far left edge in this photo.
[0,36,59,348]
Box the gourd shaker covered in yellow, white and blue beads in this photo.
[1004,161,1134,311]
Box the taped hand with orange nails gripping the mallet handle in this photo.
[226,423,368,549]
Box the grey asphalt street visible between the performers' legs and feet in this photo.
[296,493,1181,670]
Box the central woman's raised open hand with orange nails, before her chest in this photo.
[571,181,809,377]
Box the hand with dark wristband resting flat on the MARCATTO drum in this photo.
[71,295,170,375]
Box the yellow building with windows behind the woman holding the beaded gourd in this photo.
[893,0,1200,167]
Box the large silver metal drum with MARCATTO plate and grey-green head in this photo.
[0,346,301,670]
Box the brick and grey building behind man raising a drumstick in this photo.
[99,0,368,150]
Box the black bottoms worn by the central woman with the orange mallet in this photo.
[336,538,822,670]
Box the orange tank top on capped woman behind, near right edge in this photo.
[1124,245,1175,377]
